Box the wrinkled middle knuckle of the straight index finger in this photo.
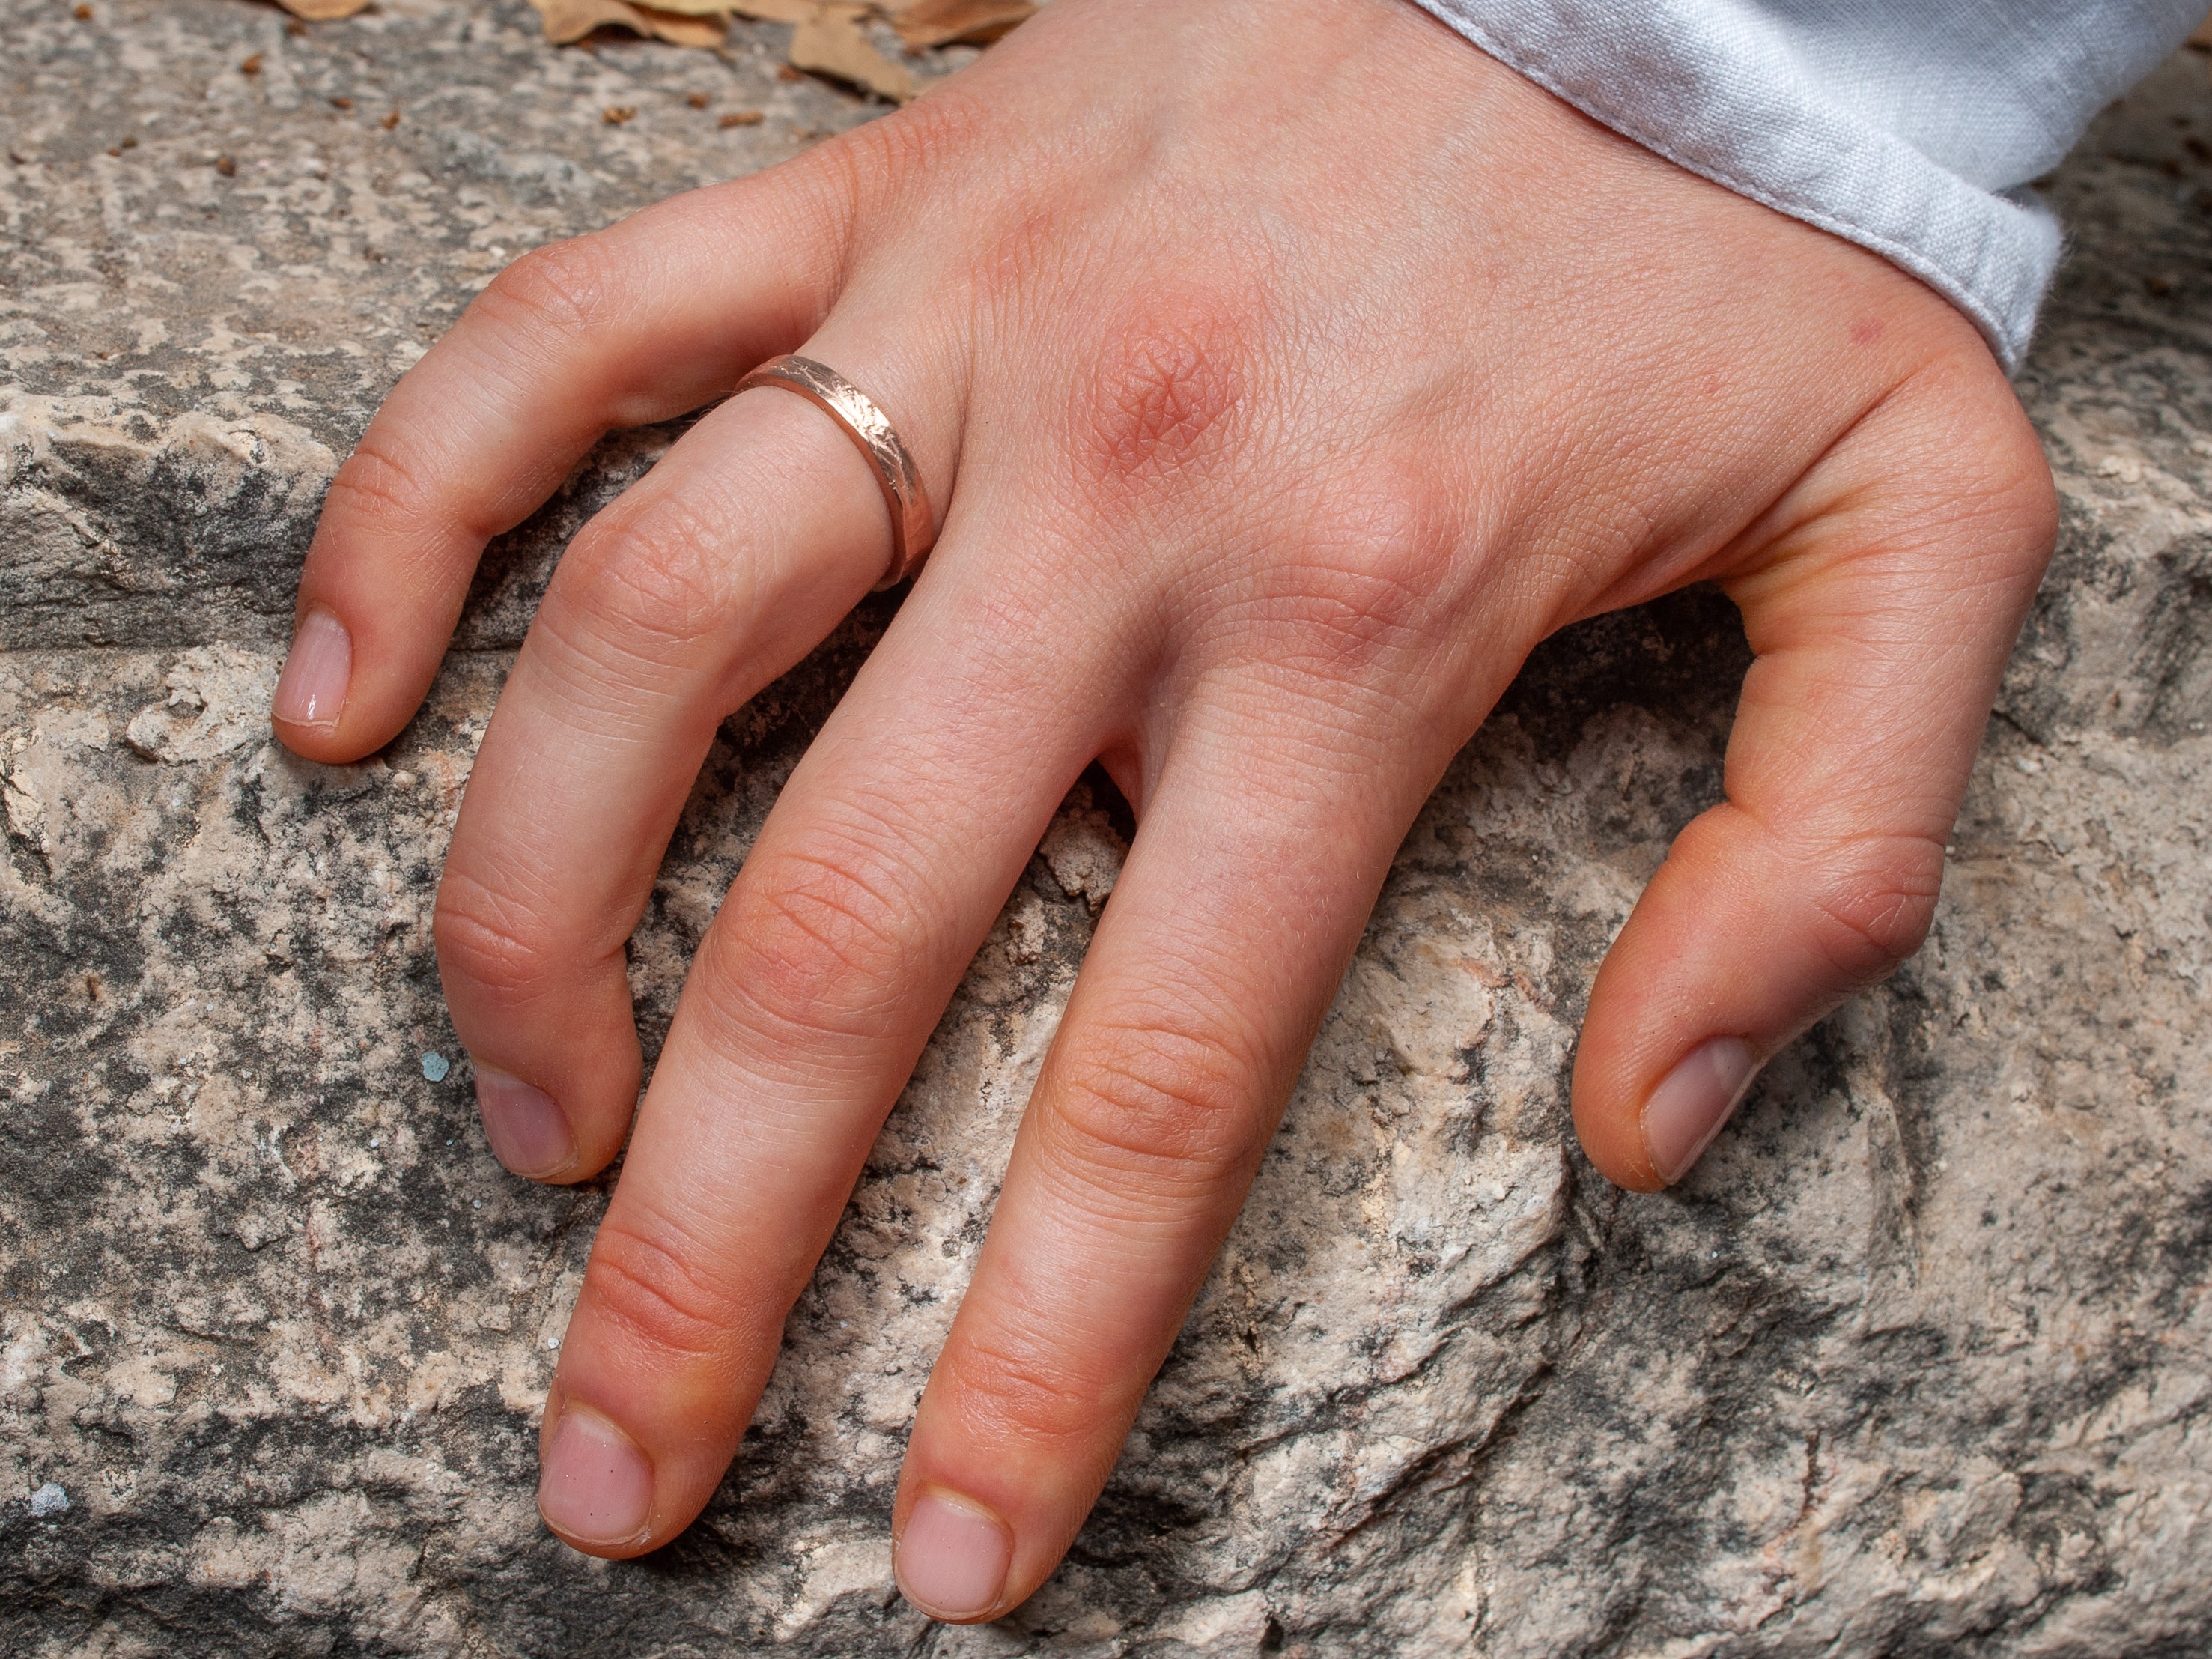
[1048,1022,1257,1201]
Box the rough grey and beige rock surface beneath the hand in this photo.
[0,0,2212,1659]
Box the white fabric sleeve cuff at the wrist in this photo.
[1416,0,2205,371]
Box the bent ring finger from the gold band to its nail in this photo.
[436,389,891,1181]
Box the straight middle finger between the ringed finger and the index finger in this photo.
[540,551,1123,1555]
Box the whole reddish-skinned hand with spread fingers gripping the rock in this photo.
[276,0,2055,1619]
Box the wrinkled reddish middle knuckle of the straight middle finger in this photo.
[701,834,916,1044]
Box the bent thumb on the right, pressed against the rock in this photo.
[1573,369,2055,1190]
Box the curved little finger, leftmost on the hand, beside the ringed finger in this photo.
[274,164,849,761]
